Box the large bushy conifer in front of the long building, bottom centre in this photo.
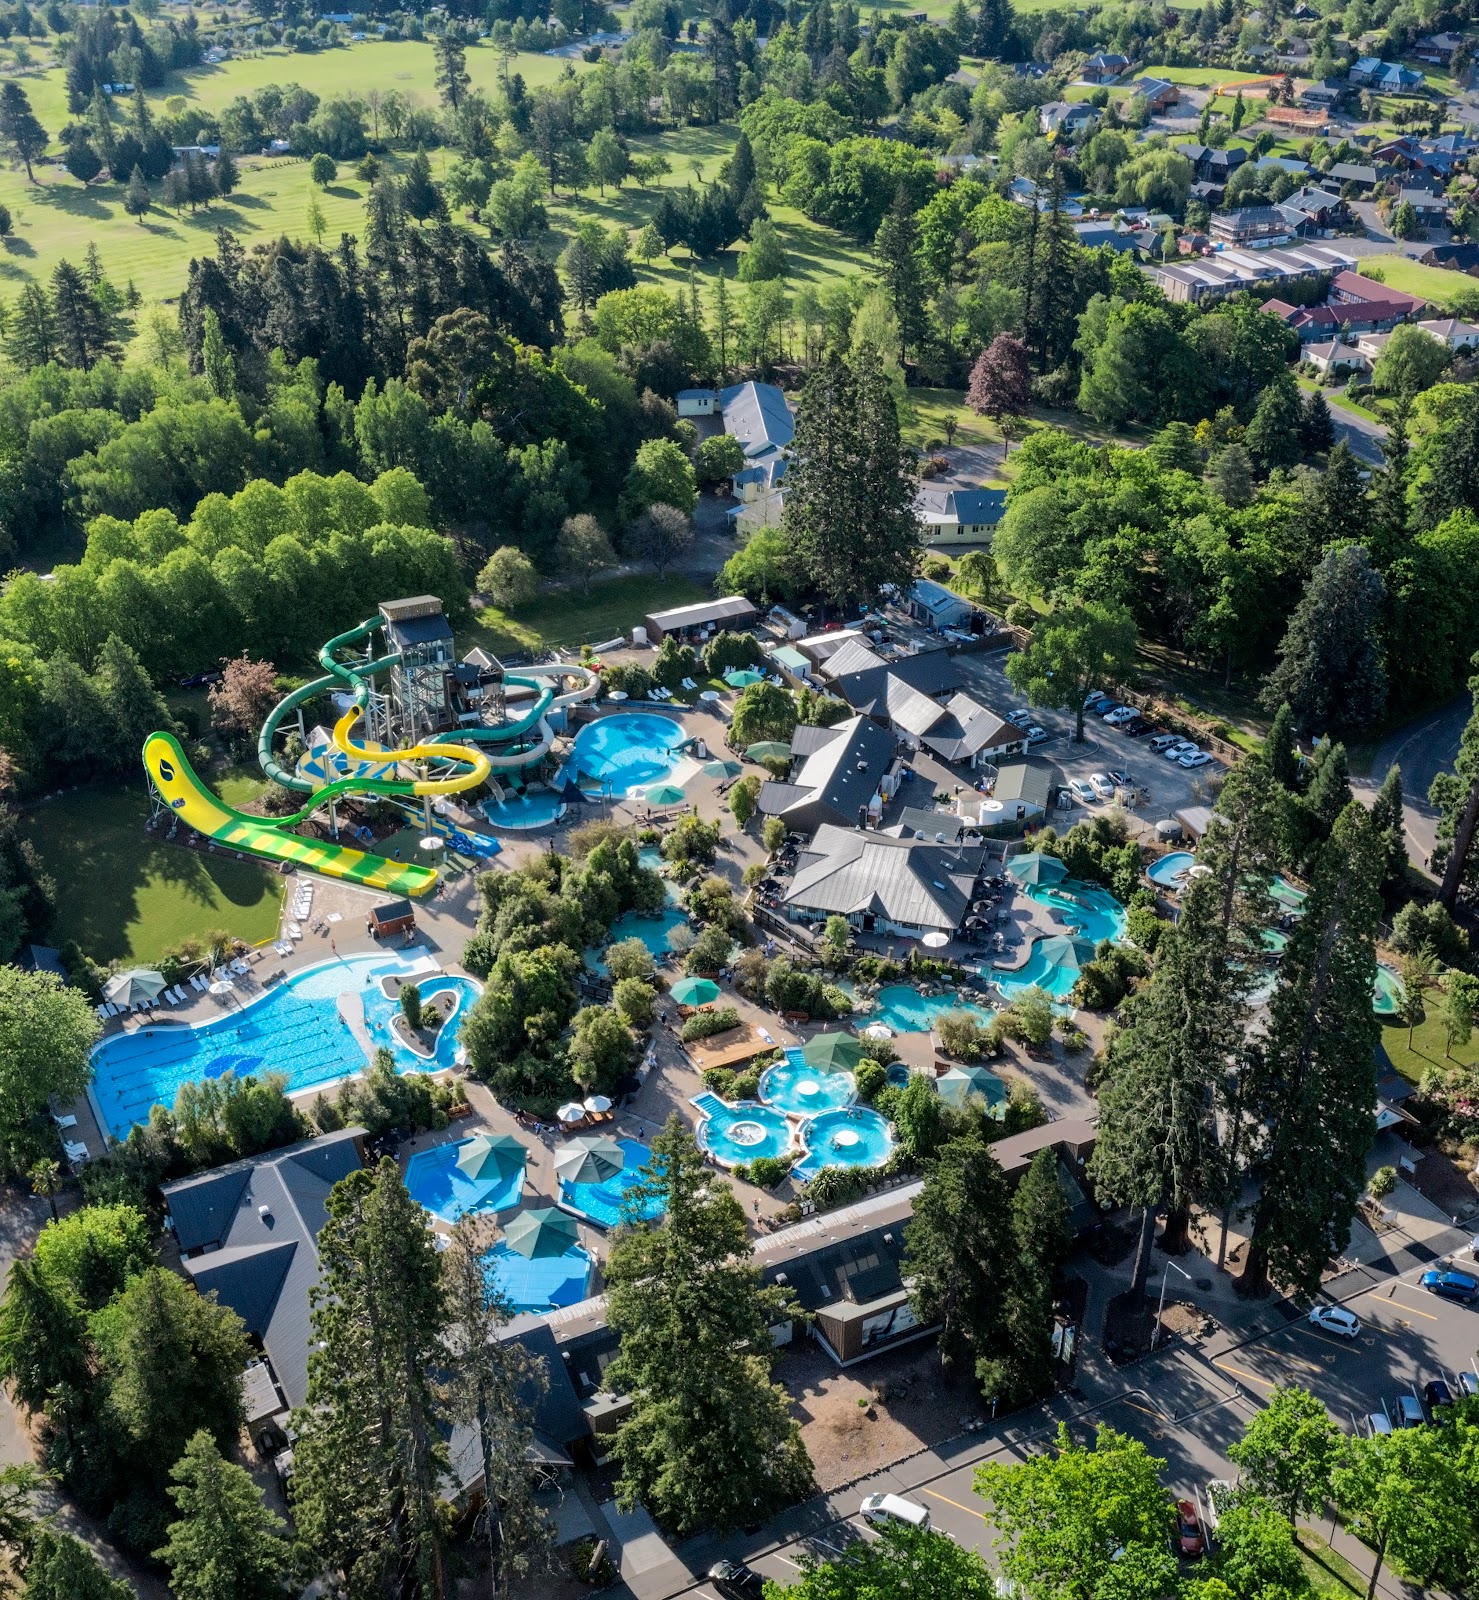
[607,1117,812,1534]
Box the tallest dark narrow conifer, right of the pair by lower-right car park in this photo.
[1239,802,1385,1294]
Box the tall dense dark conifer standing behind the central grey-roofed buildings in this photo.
[784,354,919,605]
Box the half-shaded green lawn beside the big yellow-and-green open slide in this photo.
[24,774,282,963]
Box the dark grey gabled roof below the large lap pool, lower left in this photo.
[160,1128,365,1406]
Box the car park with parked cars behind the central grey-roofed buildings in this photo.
[956,650,1226,827]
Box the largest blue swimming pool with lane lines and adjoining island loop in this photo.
[93,955,479,1139]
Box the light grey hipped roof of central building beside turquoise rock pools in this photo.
[784,826,986,933]
